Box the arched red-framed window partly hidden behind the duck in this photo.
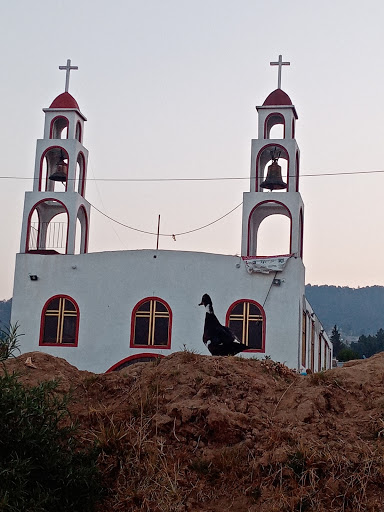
[227,300,265,352]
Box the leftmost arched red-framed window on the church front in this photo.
[40,296,79,346]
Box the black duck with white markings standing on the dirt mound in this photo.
[199,293,248,356]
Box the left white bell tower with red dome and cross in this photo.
[20,60,90,254]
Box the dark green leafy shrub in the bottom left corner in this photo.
[0,372,101,512]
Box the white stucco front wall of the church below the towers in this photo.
[11,250,318,372]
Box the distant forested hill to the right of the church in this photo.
[305,284,384,337]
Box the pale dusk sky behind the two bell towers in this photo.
[0,0,384,299]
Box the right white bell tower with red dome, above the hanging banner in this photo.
[241,55,304,258]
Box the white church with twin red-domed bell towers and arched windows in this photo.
[11,56,332,373]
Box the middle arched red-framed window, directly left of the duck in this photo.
[131,297,172,348]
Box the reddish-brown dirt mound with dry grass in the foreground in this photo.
[7,352,384,512]
